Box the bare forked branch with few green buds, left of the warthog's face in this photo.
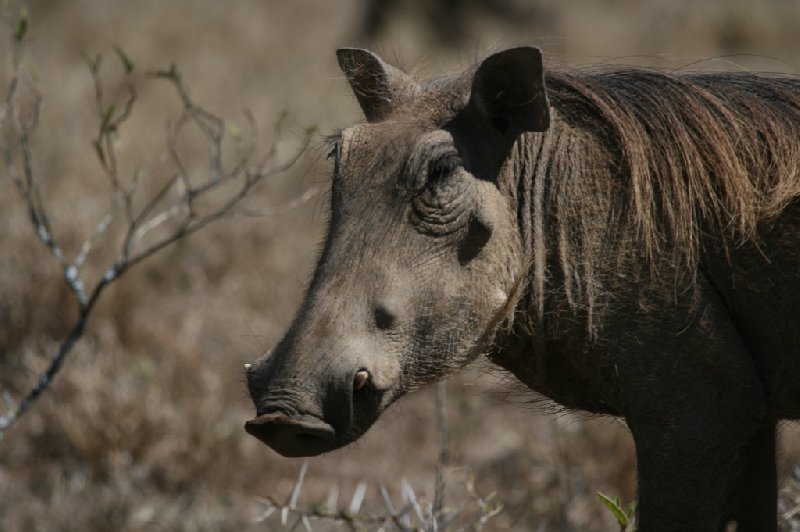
[0,10,315,436]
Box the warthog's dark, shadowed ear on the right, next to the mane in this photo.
[470,46,550,136]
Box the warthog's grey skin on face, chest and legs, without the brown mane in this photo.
[246,47,800,532]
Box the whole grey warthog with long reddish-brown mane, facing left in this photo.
[246,47,800,531]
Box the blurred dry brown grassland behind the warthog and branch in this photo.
[0,0,800,531]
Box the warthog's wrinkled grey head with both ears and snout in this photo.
[246,47,549,456]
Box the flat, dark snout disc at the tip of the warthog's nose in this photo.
[244,412,332,458]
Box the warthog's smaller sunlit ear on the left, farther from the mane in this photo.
[336,48,418,122]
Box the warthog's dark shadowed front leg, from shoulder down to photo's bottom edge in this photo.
[621,282,777,532]
